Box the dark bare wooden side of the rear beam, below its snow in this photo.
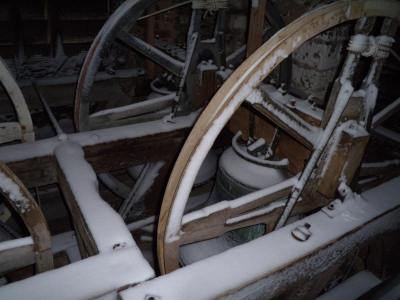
[7,129,187,188]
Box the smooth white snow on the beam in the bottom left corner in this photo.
[0,247,154,300]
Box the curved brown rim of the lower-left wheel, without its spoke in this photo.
[0,162,53,273]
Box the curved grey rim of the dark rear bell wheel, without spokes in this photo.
[74,0,157,131]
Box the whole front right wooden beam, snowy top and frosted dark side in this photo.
[119,177,400,300]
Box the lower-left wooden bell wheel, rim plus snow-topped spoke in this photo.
[0,162,53,274]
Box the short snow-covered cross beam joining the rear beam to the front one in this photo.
[55,141,136,257]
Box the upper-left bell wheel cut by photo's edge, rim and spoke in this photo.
[0,58,35,143]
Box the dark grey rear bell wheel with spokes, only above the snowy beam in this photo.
[74,0,290,131]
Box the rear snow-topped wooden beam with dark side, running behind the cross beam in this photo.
[0,113,197,187]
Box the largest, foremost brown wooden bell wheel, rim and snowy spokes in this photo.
[157,0,400,273]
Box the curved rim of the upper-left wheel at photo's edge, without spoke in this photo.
[0,58,35,142]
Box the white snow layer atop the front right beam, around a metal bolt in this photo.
[120,177,400,300]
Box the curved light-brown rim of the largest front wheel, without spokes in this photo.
[157,0,400,274]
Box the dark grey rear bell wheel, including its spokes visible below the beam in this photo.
[75,0,290,223]
